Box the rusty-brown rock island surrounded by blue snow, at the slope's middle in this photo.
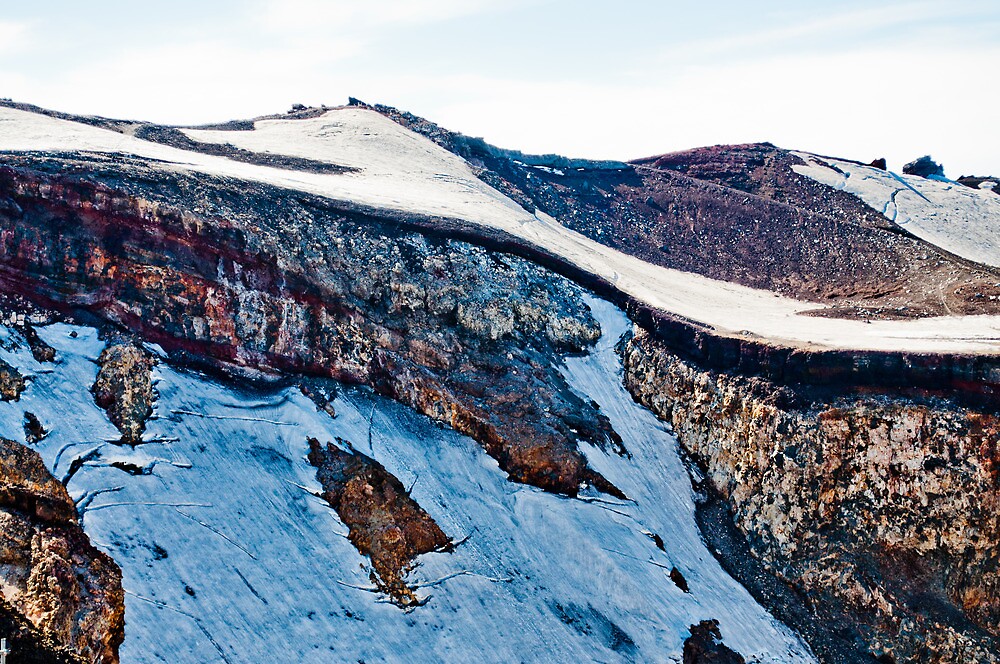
[309,438,450,606]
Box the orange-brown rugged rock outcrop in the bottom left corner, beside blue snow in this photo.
[0,438,125,662]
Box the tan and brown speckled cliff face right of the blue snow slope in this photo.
[624,331,1000,664]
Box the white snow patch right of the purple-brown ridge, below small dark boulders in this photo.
[792,152,1000,266]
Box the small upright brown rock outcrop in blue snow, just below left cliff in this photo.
[91,343,156,445]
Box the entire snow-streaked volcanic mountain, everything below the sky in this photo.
[0,99,1000,664]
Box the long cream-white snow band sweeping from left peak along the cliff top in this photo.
[0,108,1000,353]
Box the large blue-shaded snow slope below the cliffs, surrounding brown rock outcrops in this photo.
[0,312,814,664]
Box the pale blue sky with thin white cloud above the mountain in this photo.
[0,0,1000,177]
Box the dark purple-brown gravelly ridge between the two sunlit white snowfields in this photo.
[366,105,1000,319]
